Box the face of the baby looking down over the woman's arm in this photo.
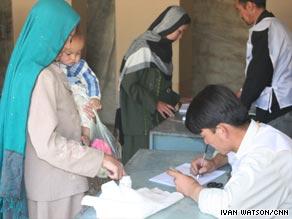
[59,38,84,66]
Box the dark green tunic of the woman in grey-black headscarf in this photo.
[120,68,179,163]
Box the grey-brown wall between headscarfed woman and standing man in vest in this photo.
[193,0,248,94]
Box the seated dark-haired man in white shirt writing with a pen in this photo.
[167,85,292,218]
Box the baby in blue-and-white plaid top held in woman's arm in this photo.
[57,26,101,145]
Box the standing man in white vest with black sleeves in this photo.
[235,0,292,137]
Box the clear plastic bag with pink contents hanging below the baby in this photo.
[90,112,122,160]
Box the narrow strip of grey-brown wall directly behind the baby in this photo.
[86,0,117,124]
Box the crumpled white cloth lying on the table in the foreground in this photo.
[81,176,183,219]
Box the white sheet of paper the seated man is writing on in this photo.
[149,163,225,186]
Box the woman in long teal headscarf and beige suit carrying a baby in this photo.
[0,0,125,219]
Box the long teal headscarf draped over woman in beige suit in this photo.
[0,0,80,219]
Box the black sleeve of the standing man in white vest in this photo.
[241,29,274,109]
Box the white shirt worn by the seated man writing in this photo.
[198,121,292,218]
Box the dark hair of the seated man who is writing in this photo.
[185,85,250,134]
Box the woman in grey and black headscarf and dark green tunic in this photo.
[120,6,191,163]
